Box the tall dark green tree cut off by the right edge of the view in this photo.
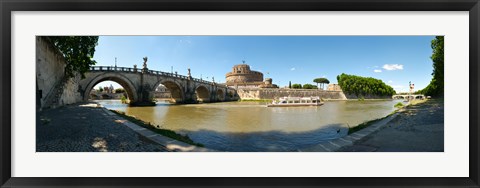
[416,36,444,96]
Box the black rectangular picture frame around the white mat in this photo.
[0,0,480,187]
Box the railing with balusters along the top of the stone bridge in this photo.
[90,66,226,87]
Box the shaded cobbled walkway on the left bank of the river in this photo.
[36,103,211,152]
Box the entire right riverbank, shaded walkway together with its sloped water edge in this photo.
[298,99,444,152]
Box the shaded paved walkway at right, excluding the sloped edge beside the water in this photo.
[335,99,444,152]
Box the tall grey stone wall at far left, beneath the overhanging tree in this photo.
[35,37,82,108]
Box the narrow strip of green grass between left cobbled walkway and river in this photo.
[110,110,204,147]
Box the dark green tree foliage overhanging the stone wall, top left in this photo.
[46,36,98,78]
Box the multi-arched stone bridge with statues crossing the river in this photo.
[79,66,238,105]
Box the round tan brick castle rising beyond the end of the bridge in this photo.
[225,61,278,88]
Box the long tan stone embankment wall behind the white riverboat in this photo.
[237,88,347,100]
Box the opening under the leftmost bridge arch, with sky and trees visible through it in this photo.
[88,80,130,104]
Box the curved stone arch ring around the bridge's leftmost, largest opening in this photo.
[83,73,138,102]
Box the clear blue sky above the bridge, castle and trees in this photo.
[94,36,434,92]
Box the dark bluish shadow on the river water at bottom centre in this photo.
[179,124,348,152]
